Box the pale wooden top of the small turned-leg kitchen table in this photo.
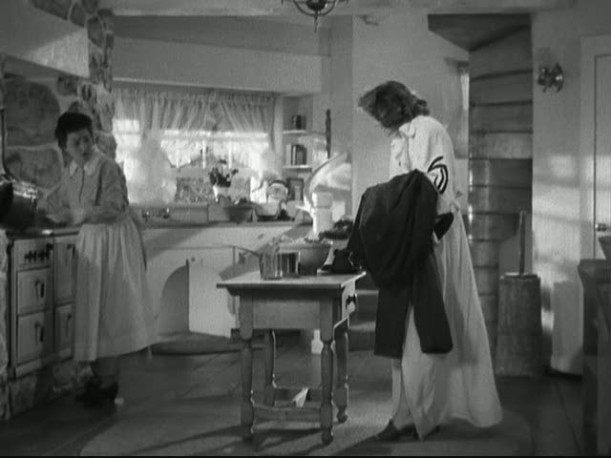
[216,271,365,290]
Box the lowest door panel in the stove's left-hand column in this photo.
[17,311,53,364]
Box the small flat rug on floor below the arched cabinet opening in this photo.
[152,332,262,355]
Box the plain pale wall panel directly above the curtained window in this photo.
[113,38,328,93]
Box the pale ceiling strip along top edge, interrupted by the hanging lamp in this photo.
[99,0,574,17]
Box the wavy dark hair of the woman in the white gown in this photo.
[358,81,429,131]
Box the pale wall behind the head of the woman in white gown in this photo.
[352,9,468,208]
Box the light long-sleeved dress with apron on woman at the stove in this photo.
[40,151,155,361]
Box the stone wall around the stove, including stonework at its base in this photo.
[0,0,116,418]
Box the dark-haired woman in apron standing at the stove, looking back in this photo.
[40,113,155,405]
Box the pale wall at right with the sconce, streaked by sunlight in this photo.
[532,0,611,373]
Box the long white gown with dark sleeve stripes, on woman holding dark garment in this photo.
[390,116,502,438]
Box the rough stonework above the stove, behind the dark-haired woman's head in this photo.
[5,0,116,188]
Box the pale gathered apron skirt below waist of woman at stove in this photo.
[73,212,155,361]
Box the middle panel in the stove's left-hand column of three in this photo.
[16,267,53,315]
